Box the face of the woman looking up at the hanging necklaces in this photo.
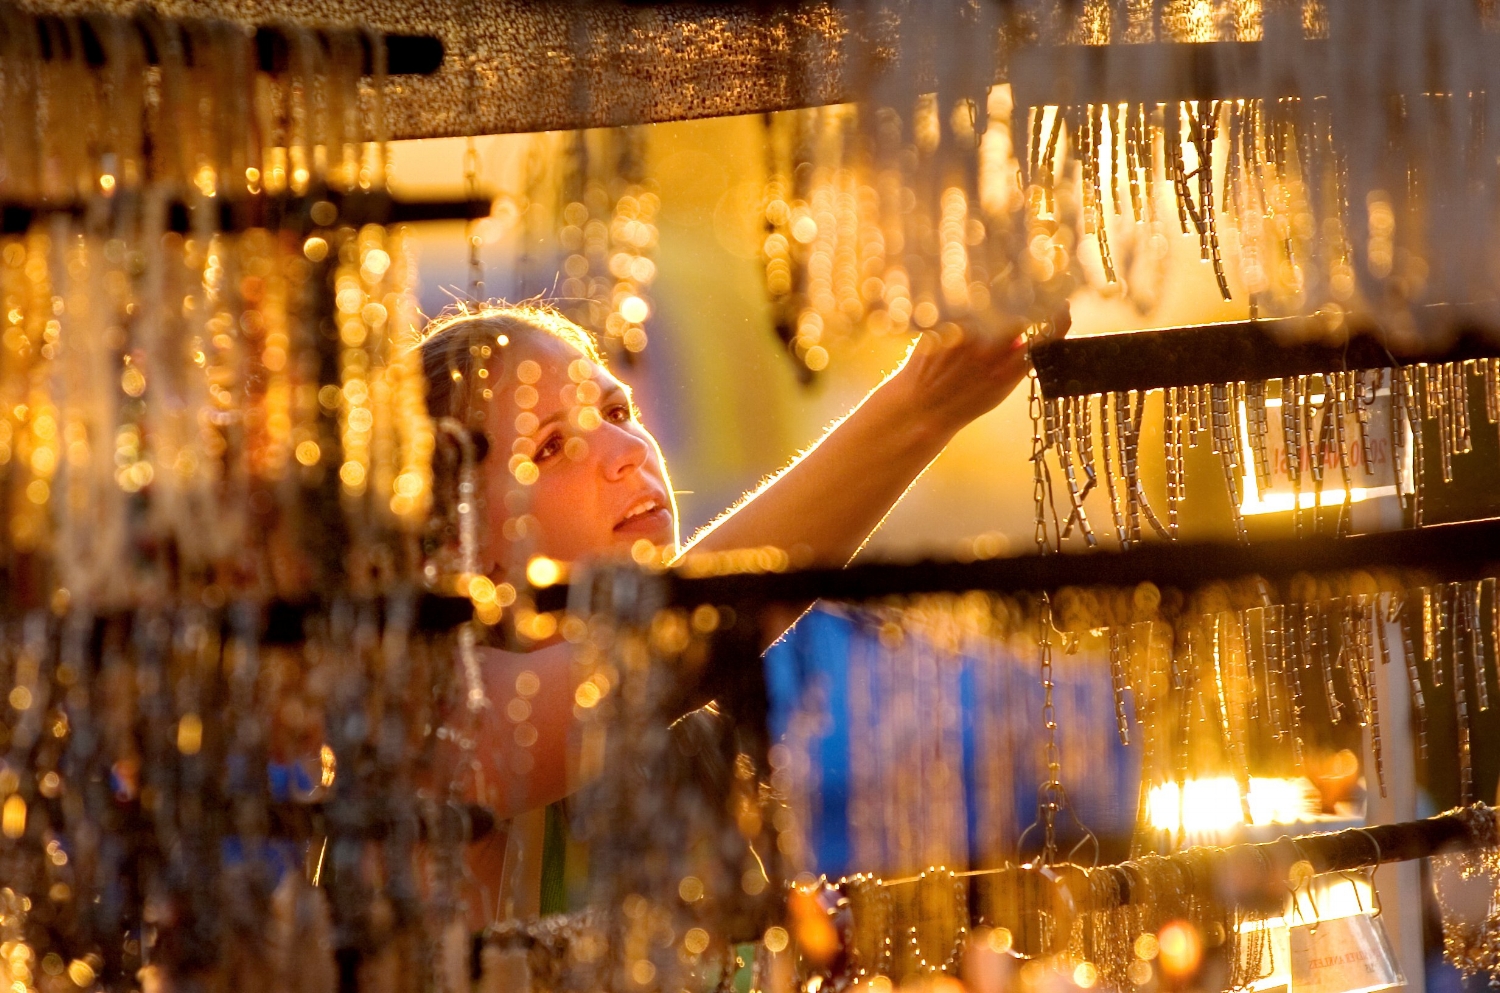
[479,332,677,575]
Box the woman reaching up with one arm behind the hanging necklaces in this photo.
[422,306,1068,914]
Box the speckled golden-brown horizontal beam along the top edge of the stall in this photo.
[20,0,1416,138]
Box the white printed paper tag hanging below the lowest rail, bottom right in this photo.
[1290,914,1406,993]
